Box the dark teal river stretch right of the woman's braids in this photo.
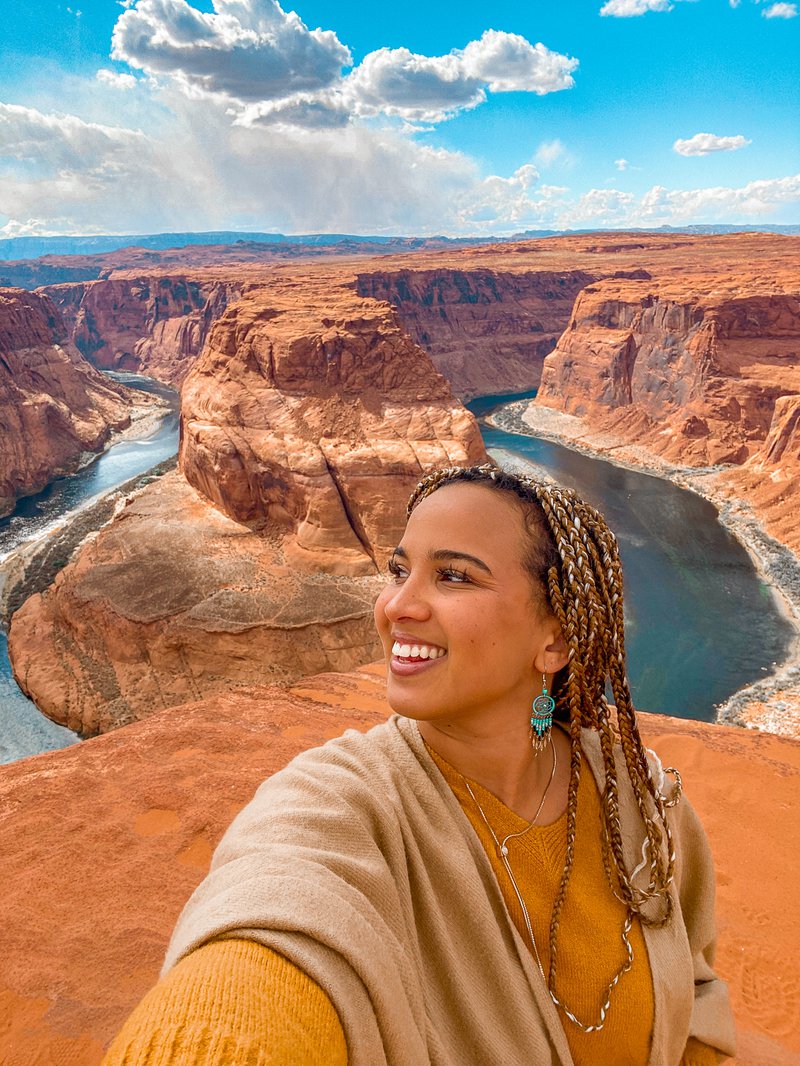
[467,392,795,722]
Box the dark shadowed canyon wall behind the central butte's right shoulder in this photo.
[357,267,594,398]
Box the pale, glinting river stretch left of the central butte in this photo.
[0,374,178,763]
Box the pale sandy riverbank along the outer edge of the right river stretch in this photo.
[486,401,800,739]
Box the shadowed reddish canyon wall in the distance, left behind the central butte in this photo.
[43,274,244,387]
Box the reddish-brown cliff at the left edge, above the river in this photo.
[0,289,147,515]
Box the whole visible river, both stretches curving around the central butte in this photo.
[0,388,794,762]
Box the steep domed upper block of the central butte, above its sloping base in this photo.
[180,279,485,574]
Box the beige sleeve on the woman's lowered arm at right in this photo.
[675,796,736,1066]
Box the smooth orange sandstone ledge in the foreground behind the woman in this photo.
[0,667,800,1066]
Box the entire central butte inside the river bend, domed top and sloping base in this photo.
[9,277,485,736]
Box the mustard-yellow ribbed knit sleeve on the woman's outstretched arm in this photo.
[102,939,348,1066]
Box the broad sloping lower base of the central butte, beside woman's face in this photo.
[9,473,386,737]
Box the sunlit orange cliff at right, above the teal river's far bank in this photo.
[537,279,800,466]
